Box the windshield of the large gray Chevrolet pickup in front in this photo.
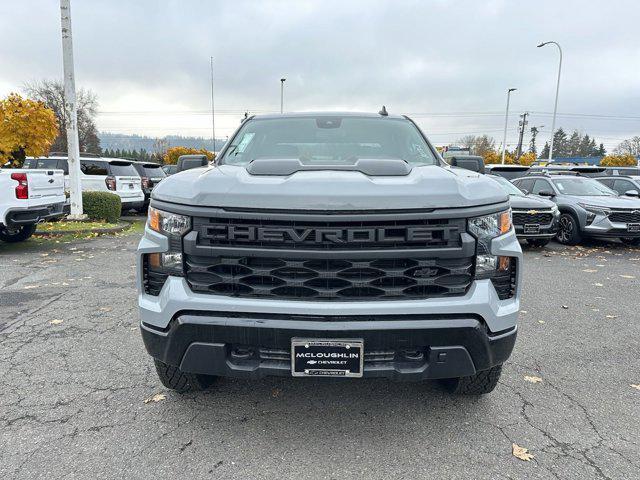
[220,115,437,165]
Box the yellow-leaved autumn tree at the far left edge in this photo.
[0,93,58,167]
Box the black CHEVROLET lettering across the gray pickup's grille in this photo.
[199,225,450,244]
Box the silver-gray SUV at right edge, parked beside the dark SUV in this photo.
[513,174,640,245]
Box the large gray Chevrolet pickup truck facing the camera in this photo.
[138,110,522,395]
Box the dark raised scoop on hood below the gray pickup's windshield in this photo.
[246,158,411,177]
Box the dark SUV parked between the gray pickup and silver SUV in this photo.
[487,175,560,247]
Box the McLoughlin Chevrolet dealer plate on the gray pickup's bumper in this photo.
[291,338,364,378]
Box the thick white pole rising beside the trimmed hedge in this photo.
[60,0,86,220]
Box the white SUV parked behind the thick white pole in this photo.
[25,155,144,210]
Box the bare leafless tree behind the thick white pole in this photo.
[24,80,101,154]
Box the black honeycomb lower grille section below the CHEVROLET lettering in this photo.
[185,255,473,301]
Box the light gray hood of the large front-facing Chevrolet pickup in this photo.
[152,165,508,211]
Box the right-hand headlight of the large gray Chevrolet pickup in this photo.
[469,209,512,278]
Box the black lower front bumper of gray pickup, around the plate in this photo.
[141,314,516,381]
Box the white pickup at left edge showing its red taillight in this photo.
[0,168,66,242]
